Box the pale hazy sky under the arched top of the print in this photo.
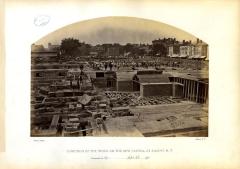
[35,17,197,46]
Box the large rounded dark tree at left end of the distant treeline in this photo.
[60,38,80,56]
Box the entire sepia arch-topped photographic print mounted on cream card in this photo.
[31,16,209,137]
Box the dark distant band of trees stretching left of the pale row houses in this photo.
[60,38,167,57]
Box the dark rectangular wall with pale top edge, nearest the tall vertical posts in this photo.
[140,83,173,97]
